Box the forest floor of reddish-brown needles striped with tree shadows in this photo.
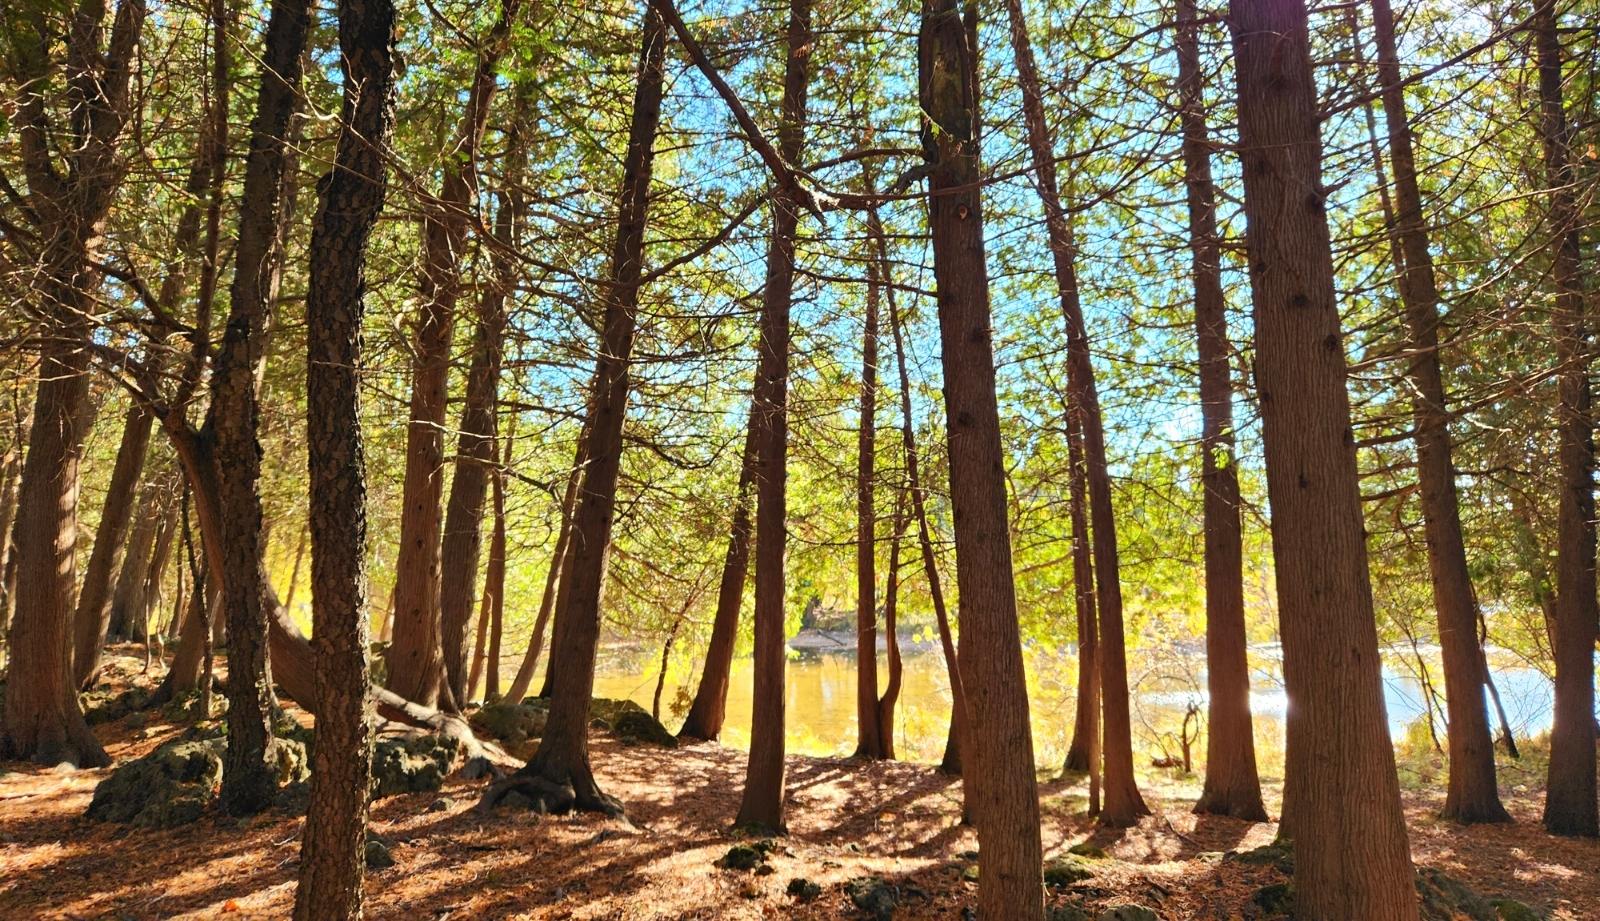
[0,652,1600,921]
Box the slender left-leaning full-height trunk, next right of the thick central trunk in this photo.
[1006,0,1150,827]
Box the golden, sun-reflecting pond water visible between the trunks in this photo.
[579,643,1554,772]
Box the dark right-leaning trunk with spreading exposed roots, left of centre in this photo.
[485,6,667,814]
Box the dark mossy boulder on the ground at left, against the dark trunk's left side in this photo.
[85,740,222,828]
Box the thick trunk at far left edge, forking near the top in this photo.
[0,0,146,768]
